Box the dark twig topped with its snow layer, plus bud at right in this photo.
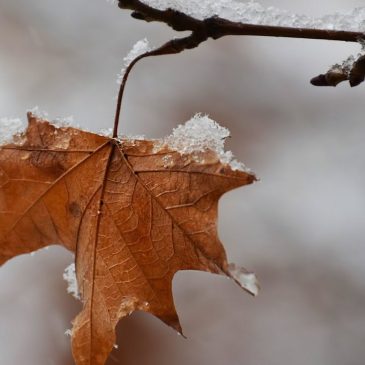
[118,0,365,86]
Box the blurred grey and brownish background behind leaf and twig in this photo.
[0,0,365,365]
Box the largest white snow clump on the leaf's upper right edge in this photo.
[162,114,250,172]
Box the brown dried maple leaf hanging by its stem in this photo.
[0,114,255,365]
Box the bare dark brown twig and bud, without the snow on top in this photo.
[117,0,365,91]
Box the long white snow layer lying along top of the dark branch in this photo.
[142,0,365,32]
